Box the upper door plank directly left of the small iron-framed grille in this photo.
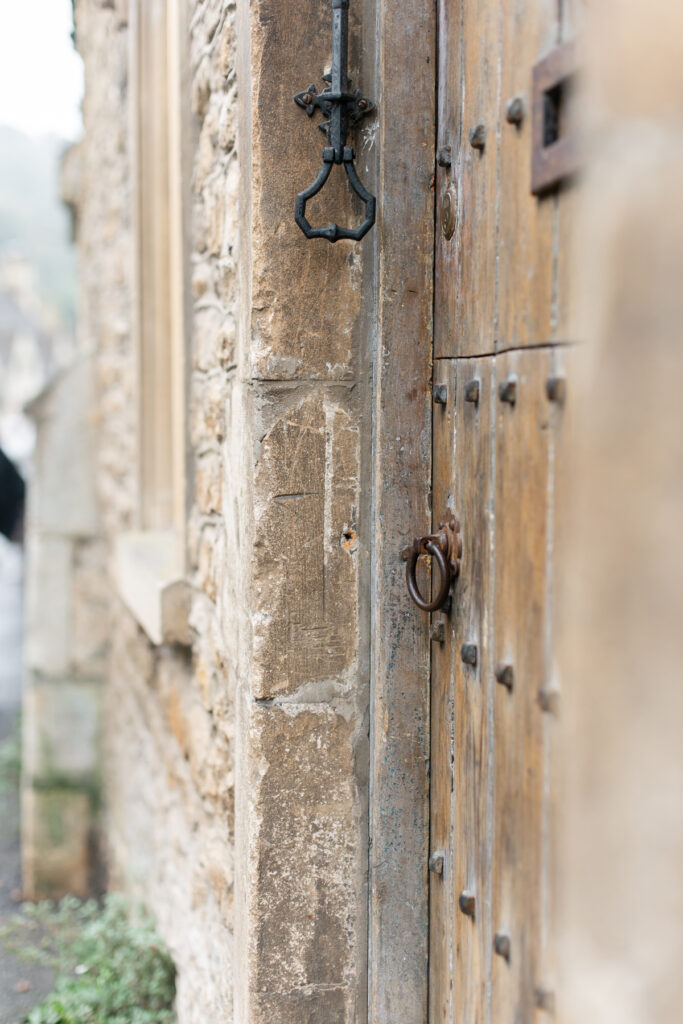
[497,0,558,348]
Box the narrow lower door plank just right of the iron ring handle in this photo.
[452,358,495,1022]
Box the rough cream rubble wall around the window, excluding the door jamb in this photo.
[76,0,238,1024]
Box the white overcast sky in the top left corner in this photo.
[0,0,83,141]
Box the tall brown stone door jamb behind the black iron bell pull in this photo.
[233,0,371,1024]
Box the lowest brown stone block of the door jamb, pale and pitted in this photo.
[244,701,366,1024]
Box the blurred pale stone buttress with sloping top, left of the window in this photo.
[22,356,108,899]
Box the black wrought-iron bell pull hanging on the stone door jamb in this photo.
[294,0,376,242]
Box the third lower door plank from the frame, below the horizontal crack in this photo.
[492,349,550,1022]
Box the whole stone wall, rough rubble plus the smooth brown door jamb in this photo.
[69,0,371,1024]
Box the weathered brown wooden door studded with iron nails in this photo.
[429,0,574,1024]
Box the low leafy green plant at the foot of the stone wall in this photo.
[0,894,175,1024]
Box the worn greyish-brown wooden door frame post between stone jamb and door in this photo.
[369,0,436,1024]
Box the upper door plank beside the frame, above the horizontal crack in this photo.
[434,0,501,356]
